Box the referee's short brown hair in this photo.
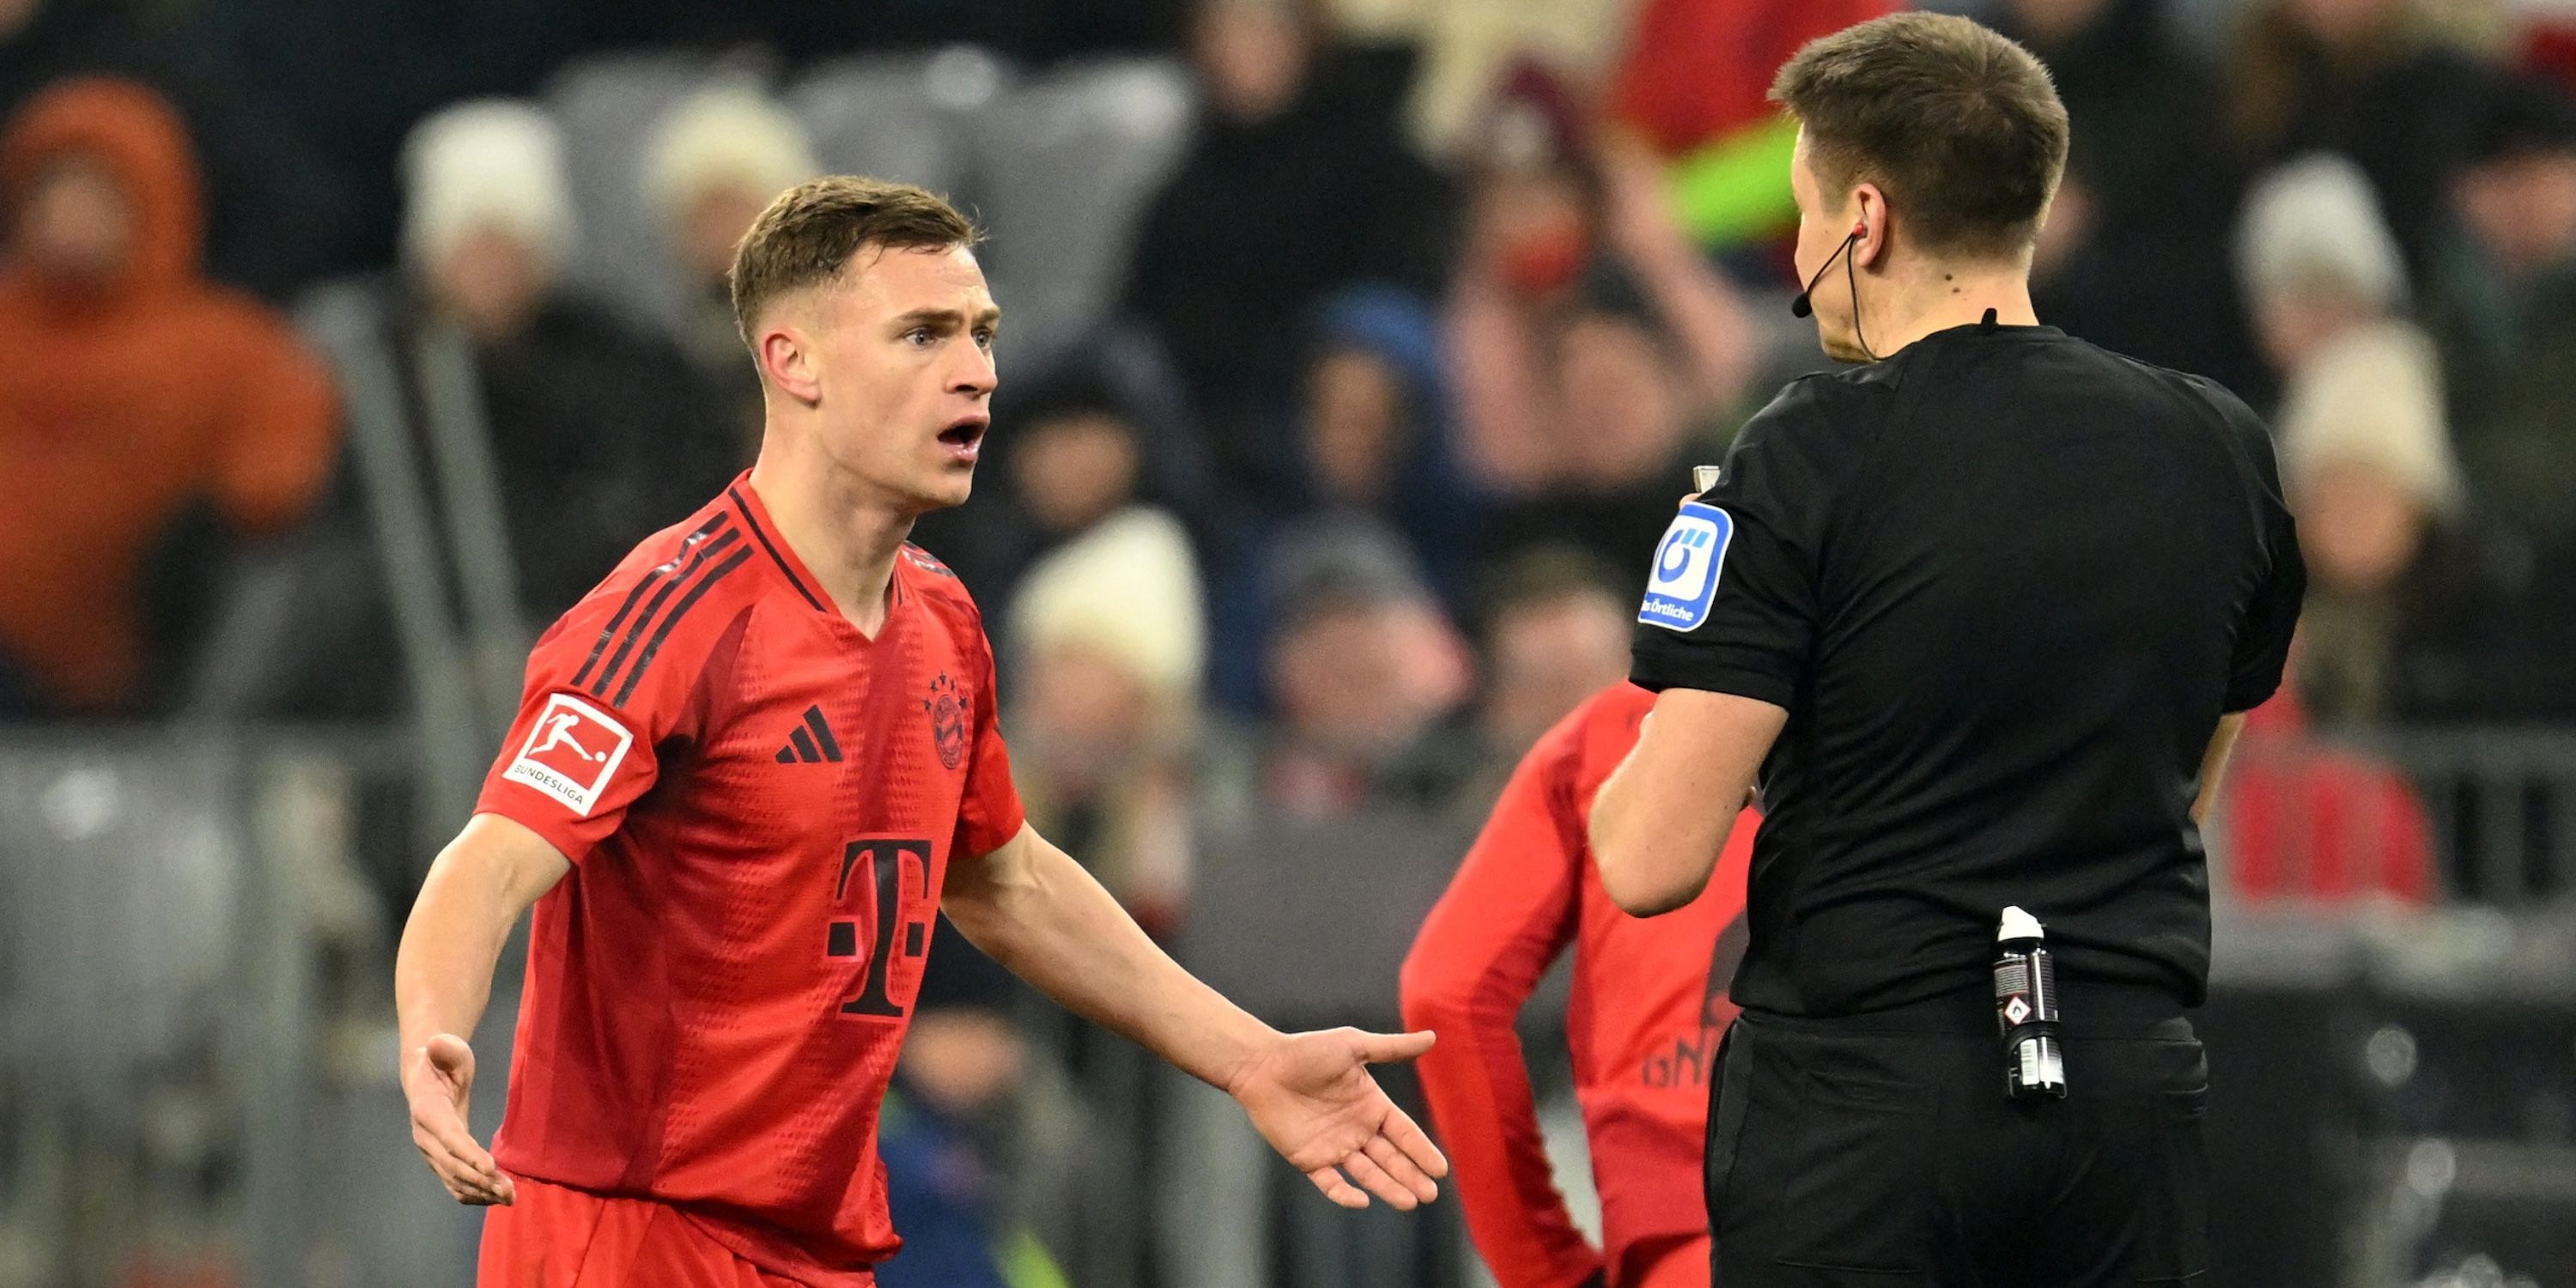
[1770,13,2069,255]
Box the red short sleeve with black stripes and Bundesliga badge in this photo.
[474,587,696,863]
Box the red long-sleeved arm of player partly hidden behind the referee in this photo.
[1404,737,1602,1288]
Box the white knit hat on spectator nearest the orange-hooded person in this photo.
[402,98,574,268]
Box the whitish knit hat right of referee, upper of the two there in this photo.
[2236,152,2406,312]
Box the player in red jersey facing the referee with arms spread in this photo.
[394,178,1448,1288]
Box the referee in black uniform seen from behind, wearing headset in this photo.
[1592,13,2303,1288]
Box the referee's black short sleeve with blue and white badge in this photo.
[1628,379,1850,708]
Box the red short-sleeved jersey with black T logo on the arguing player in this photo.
[477,477,1020,1285]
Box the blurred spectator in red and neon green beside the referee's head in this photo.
[1610,0,1904,245]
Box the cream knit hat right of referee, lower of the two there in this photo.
[2280,322,2463,513]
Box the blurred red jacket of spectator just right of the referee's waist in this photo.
[2215,690,2439,907]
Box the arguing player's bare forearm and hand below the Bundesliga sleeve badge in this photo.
[394,814,572,1203]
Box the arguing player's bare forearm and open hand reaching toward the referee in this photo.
[940,827,1448,1208]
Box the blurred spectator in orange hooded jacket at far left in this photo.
[0,80,335,714]
